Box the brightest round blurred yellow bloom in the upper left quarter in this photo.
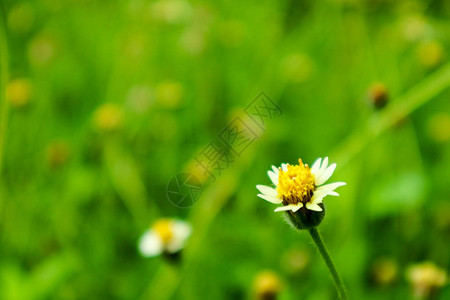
[94,103,123,132]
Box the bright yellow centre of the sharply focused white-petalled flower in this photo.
[277,159,316,205]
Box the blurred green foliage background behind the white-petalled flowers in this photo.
[0,0,450,299]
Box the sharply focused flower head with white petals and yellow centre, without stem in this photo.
[256,157,346,212]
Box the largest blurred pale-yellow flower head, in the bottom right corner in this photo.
[406,262,447,299]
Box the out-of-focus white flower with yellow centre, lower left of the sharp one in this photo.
[138,219,192,257]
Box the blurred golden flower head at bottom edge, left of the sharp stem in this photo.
[253,271,282,300]
